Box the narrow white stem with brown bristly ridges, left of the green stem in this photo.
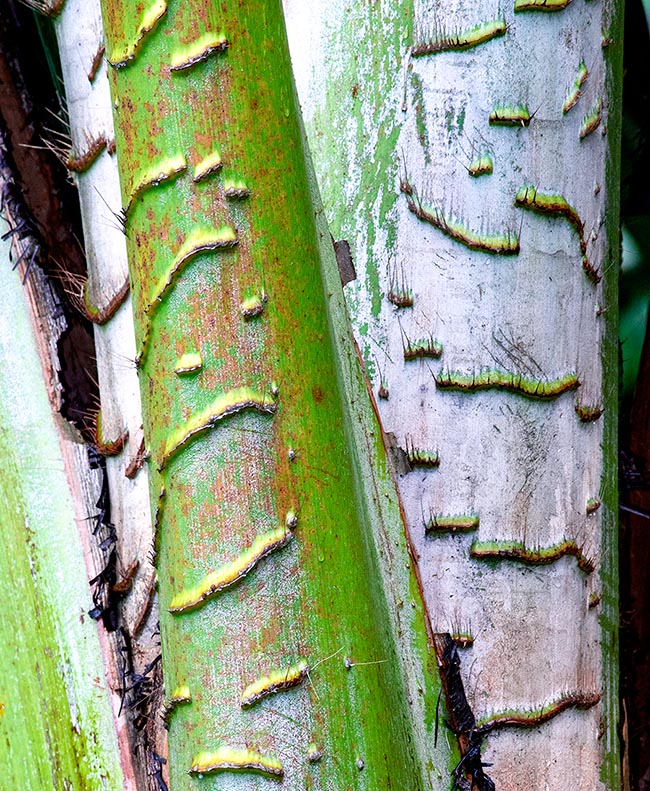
[55,0,166,791]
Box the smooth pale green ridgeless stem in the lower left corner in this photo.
[0,238,123,791]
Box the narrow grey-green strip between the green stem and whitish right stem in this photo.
[308,160,460,789]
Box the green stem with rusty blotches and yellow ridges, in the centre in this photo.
[103,0,421,791]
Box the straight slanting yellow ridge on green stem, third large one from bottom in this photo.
[169,526,293,614]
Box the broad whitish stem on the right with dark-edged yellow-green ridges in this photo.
[285,0,622,789]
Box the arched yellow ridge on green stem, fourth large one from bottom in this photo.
[158,387,277,472]
